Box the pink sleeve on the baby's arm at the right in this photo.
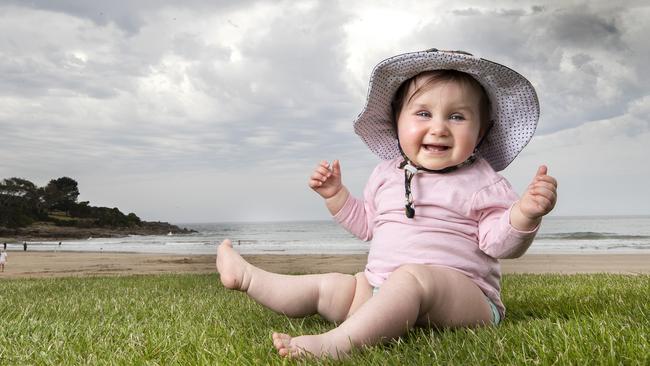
[472,179,539,258]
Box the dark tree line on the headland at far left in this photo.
[0,177,191,237]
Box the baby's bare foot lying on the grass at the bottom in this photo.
[273,333,350,359]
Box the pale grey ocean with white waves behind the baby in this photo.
[8,216,650,255]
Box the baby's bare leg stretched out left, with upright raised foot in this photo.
[217,239,356,322]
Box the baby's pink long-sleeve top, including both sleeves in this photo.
[334,159,537,317]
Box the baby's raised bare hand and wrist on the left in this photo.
[309,160,350,216]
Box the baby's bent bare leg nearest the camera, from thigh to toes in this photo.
[273,265,491,358]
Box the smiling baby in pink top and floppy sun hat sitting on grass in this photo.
[216,49,557,358]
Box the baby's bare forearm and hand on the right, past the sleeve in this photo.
[510,165,557,231]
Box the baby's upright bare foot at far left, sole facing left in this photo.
[217,239,252,291]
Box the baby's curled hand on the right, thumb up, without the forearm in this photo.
[519,165,557,220]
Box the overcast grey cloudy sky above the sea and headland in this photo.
[0,0,650,223]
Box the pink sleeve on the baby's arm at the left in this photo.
[334,168,378,241]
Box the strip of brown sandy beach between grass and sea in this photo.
[0,251,650,278]
